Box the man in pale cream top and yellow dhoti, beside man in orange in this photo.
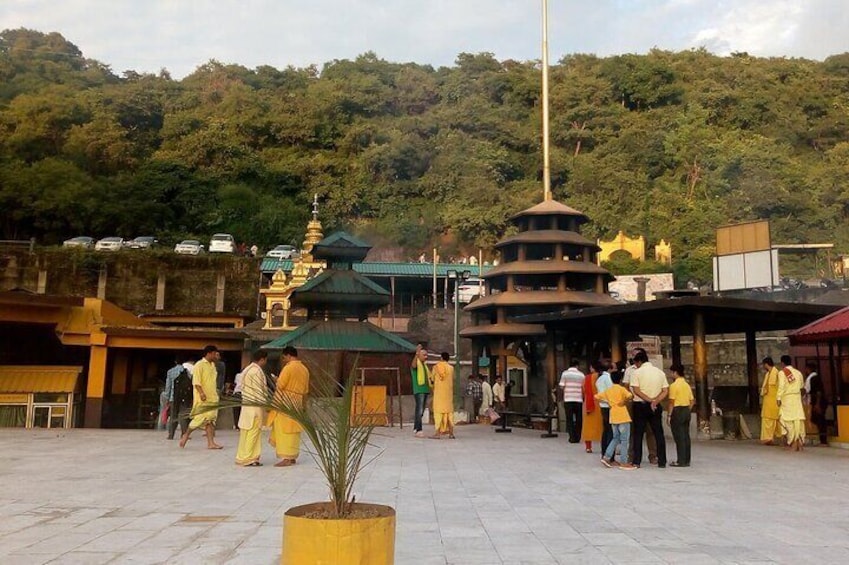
[236,350,268,467]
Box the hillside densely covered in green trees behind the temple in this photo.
[0,30,849,278]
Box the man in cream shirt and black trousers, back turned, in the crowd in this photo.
[631,351,669,469]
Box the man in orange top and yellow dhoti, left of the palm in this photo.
[268,346,310,467]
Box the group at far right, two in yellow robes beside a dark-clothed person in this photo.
[761,355,828,451]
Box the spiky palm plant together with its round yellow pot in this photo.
[232,352,395,565]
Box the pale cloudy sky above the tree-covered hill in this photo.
[0,0,849,78]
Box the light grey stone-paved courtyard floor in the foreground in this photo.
[0,426,849,565]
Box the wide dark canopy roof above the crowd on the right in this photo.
[511,296,840,336]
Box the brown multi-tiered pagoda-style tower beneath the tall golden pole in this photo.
[460,200,616,406]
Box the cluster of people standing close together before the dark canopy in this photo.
[559,349,695,470]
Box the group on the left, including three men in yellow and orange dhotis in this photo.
[165,345,310,467]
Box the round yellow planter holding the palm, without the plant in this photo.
[280,502,395,565]
